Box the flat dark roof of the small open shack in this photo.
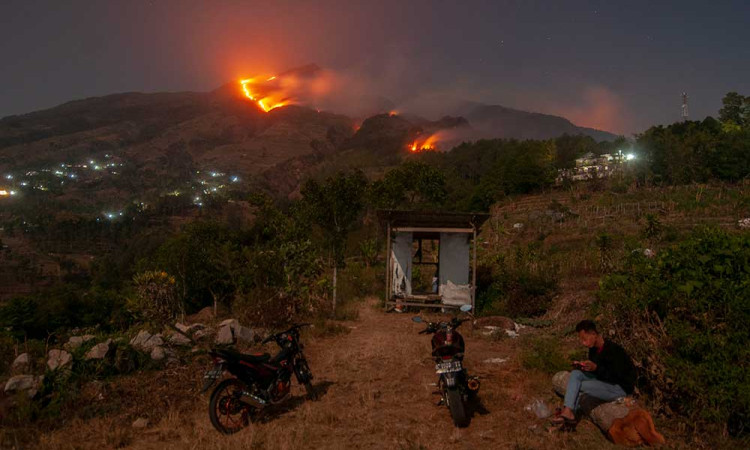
[377,209,490,230]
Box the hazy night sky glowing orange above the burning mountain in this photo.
[0,0,750,135]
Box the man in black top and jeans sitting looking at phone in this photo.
[557,320,636,422]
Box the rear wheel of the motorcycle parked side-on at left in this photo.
[208,378,254,434]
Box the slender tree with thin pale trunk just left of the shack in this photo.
[301,171,368,311]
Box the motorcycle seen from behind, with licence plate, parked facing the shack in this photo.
[412,305,480,427]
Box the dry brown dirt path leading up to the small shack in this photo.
[36,301,609,450]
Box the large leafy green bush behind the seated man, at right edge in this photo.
[599,229,750,434]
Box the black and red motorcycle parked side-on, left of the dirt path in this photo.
[201,323,316,434]
